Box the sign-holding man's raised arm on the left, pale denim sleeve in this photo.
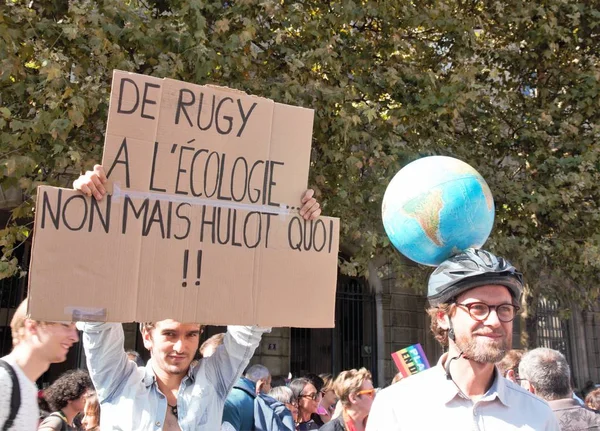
[77,322,137,402]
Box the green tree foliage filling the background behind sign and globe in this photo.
[0,0,600,316]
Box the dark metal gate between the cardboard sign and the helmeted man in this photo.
[290,275,377,381]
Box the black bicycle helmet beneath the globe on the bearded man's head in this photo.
[427,248,523,307]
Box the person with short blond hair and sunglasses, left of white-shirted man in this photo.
[319,368,376,431]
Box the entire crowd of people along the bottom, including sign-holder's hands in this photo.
[0,170,600,431]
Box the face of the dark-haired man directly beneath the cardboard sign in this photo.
[144,319,200,374]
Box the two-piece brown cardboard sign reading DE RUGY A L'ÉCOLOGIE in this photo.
[29,71,339,327]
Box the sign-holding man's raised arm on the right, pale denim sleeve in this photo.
[204,326,271,399]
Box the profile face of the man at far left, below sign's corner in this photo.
[33,322,79,364]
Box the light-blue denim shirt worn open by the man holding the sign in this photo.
[78,323,270,431]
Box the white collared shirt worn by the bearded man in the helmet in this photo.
[367,354,560,431]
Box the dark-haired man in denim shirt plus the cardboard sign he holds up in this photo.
[28,71,339,431]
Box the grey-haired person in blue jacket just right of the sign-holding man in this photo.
[223,364,271,431]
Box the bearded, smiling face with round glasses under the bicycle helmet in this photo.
[438,285,513,363]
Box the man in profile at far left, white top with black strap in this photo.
[0,299,79,430]
